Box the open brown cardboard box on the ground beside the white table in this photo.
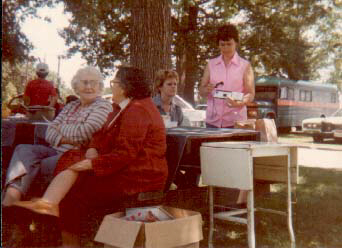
[95,206,203,248]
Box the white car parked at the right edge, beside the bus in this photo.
[302,108,342,143]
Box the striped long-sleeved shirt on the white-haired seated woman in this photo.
[45,97,113,152]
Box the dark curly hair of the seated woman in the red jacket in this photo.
[116,66,152,99]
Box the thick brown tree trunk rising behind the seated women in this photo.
[130,0,172,89]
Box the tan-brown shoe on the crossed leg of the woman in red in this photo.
[14,198,59,217]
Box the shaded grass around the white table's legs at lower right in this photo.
[201,167,342,248]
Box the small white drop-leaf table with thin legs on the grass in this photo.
[200,141,298,248]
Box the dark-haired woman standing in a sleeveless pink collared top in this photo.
[200,24,255,128]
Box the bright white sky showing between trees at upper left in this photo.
[22,4,109,88]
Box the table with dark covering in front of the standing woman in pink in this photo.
[165,127,260,191]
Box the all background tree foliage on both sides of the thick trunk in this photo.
[11,0,334,102]
